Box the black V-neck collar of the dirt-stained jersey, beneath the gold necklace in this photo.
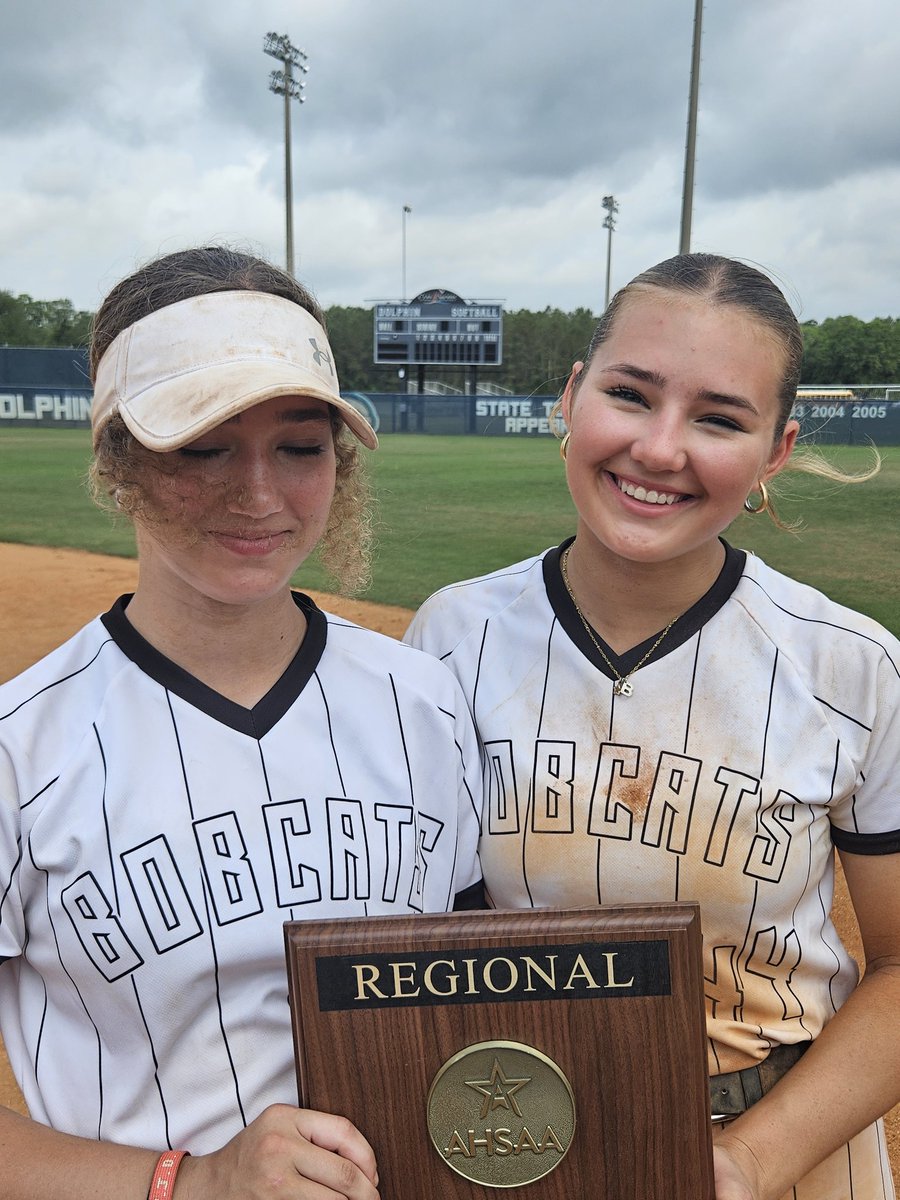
[544,538,746,680]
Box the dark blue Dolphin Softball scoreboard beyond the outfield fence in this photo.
[374,288,503,367]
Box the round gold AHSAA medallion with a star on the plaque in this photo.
[427,1042,575,1188]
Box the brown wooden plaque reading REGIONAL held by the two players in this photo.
[284,904,714,1200]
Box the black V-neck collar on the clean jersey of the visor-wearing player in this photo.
[101,592,328,739]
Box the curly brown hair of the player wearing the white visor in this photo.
[89,246,372,594]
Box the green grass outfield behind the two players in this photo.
[0,428,900,634]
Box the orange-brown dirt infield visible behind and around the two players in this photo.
[0,544,900,1192]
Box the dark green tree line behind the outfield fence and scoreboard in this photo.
[0,290,900,396]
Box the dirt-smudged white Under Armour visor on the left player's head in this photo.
[91,292,378,451]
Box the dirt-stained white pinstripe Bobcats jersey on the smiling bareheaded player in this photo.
[407,547,900,1074]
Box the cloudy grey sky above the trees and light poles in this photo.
[0,0,900,319]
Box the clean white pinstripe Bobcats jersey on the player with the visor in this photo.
[0,598,481,1152]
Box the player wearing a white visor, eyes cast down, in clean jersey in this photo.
[0,247,481,1200]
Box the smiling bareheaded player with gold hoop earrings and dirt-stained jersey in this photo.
[407,254,900,1200]
